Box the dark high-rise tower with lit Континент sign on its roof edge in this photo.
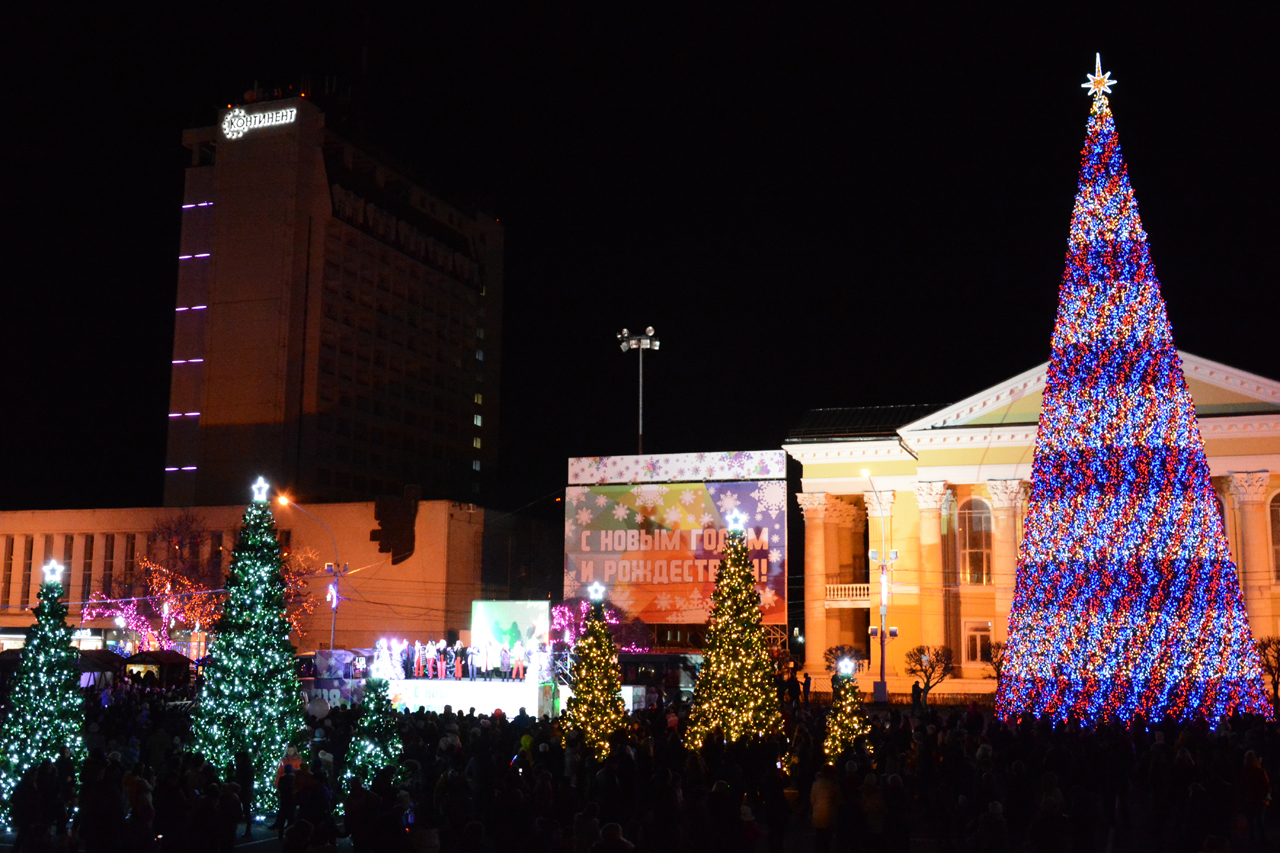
[165,97,503,506]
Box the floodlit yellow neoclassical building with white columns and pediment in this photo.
[783,352,1280,693]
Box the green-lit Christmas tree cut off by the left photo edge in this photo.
[0,562,84,820]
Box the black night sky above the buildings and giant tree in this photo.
[0,3,1280,508]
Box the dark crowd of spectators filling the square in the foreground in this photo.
[12,686,1280,853]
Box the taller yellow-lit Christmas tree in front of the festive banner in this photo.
[686,520,782,745]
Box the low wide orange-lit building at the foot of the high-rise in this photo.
[0,501,483,652]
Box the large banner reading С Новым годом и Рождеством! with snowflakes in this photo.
[564,455,787,624]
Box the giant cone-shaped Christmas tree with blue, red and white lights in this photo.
[996,56,1270,720]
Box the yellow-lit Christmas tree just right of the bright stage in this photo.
[564,587,626,758]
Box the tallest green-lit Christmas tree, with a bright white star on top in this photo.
[193,478,303,808]
